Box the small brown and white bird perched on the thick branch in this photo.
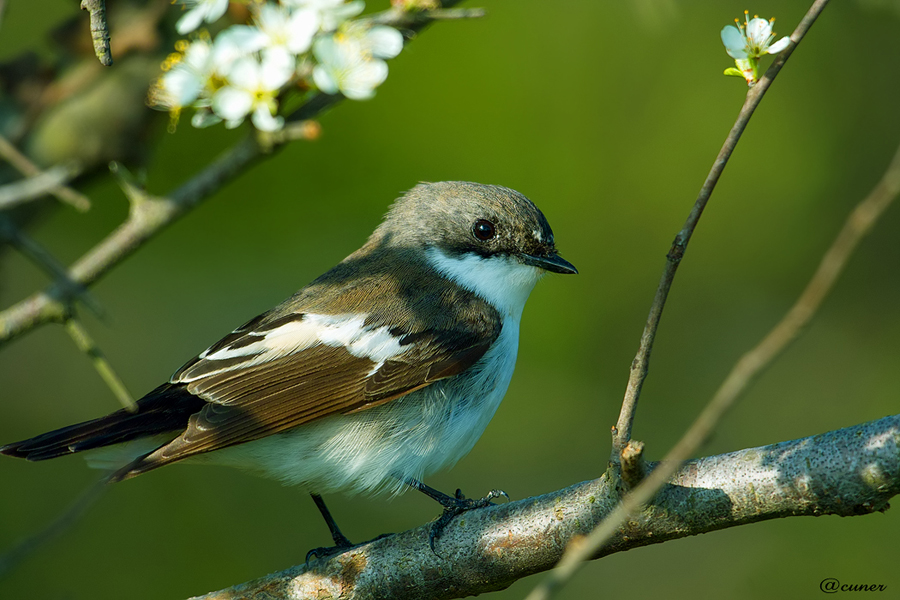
[0,182,577,552]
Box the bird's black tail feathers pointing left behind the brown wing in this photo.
[0,383,206,460]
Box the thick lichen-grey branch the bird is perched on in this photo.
[197,415,900,600]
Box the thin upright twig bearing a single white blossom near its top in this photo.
[610,0,828,464]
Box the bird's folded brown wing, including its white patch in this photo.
[114,314,500,479]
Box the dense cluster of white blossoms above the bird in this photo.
[156,0,403,131]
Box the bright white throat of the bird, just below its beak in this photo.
[425,247,543,321]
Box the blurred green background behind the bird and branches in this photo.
[0,0,900,600]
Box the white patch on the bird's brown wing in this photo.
[174,313,406,383]
